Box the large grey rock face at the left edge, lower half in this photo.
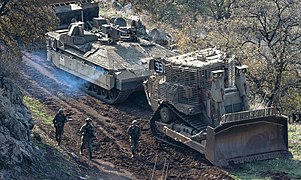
[0,76,35,179]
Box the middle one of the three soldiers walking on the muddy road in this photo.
[80,118,95,159]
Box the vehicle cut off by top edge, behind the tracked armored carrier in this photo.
[48,0,99,29]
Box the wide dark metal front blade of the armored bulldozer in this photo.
[205,115,292,166]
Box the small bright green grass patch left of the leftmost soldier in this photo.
[23,96,53,125]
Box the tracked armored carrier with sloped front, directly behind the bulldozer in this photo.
[46,17,175,104]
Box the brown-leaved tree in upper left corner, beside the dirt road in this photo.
[0,0,58,76]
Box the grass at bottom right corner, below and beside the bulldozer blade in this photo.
[229,125,301,180]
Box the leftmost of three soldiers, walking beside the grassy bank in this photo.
[53,108,67,146]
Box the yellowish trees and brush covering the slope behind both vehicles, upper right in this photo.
[120,0,301,114]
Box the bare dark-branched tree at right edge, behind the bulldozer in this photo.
[236,0,301,112]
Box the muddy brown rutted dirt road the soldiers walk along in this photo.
[18,51,231,179]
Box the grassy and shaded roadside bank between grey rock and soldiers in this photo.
[23,96,102,180]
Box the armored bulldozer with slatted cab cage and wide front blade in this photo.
[144,48,292,166]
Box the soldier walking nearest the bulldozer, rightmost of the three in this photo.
[127,120,141,158]
